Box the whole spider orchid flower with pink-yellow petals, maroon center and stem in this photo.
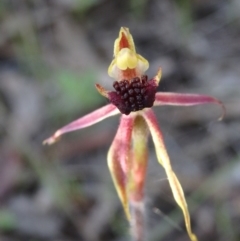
[44,27,225,241]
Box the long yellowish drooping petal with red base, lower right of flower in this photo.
[143,109,197,241]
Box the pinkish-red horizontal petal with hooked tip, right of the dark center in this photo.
[154,92,226,120]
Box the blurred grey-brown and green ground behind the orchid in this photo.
[0,0,240,241]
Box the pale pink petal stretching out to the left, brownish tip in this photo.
[43,104,119,145]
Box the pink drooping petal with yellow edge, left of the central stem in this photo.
[107,115,134,220]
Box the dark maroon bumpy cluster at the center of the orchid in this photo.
[109,75,157,115]
